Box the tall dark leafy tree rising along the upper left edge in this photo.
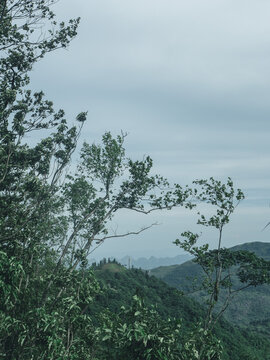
[0,0,85,262]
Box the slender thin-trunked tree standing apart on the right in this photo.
[175,178,270,359]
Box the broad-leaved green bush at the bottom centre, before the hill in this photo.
[96,295,183,360]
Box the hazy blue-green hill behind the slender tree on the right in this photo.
[151,242,270,334]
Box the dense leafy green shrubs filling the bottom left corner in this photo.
[0,252,99,359]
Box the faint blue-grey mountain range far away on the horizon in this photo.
[89,254,191,270]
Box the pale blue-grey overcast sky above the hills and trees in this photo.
[31,0,270,258]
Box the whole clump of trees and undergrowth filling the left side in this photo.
[0,0,194,360]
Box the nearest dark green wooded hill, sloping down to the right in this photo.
[91,263,270,360]
